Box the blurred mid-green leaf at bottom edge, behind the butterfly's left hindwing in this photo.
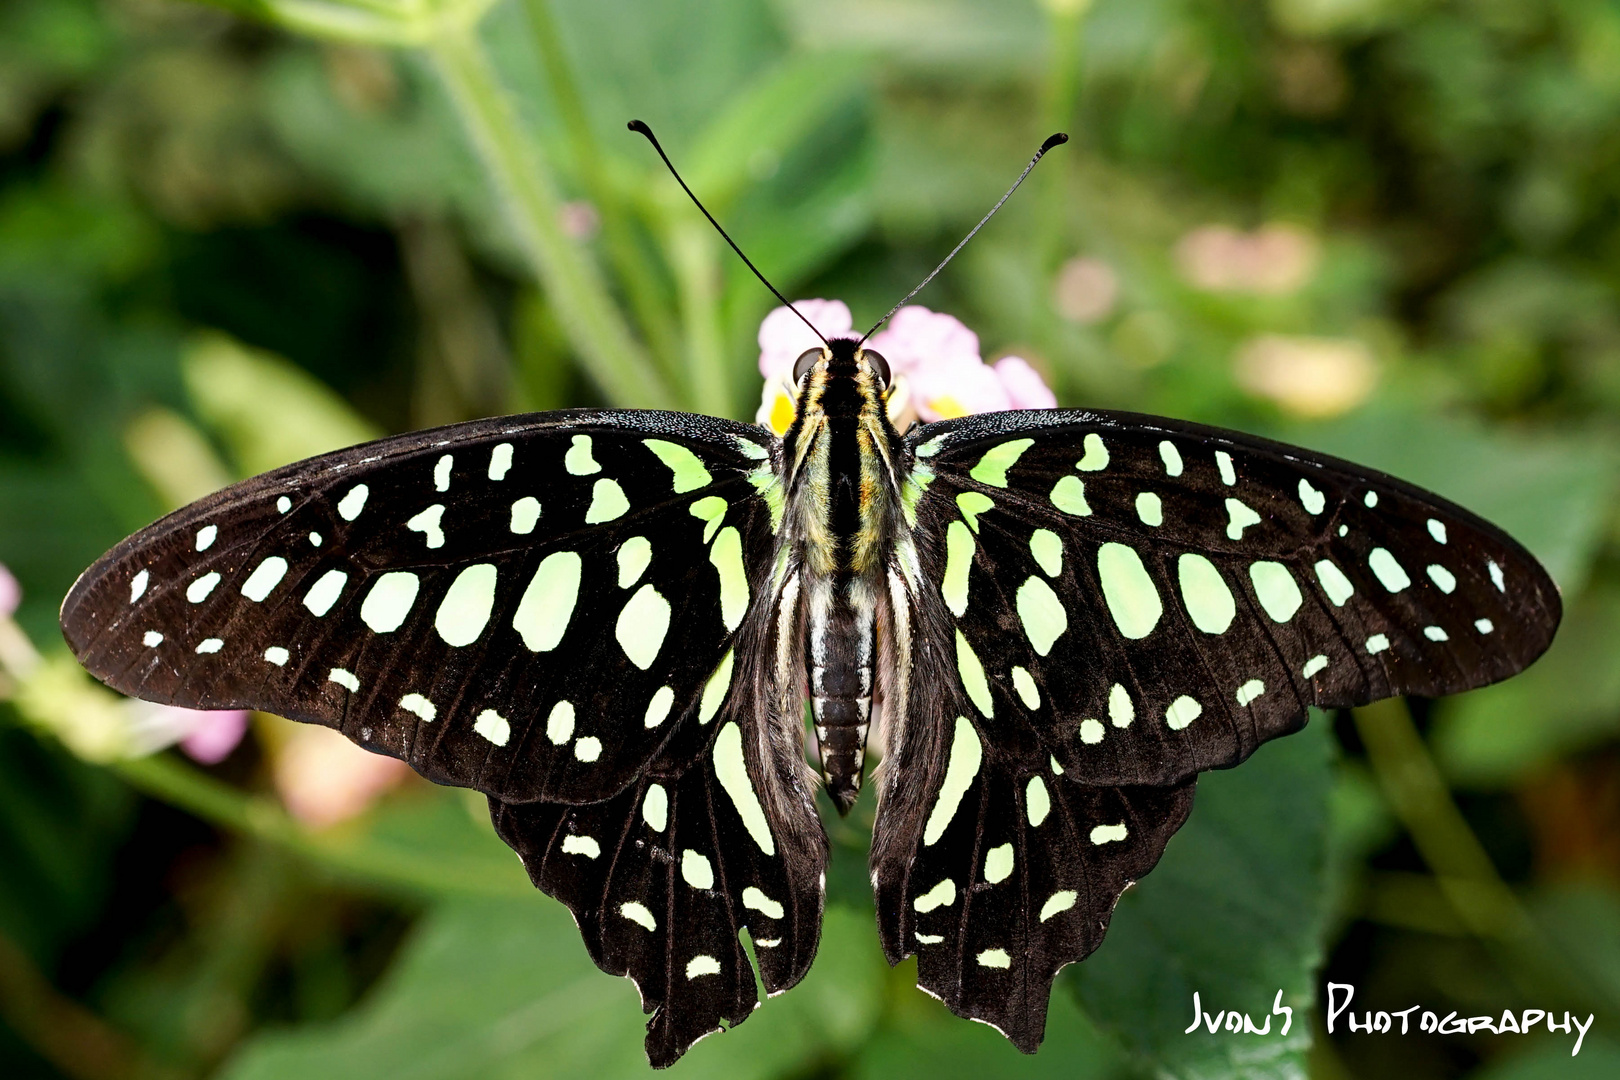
[222,895,883,1080]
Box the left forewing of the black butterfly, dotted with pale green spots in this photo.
[62,411,774,801]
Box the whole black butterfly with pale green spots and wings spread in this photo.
[62,124,1560,1065]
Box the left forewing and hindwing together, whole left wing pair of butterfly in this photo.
[62,410,826,1064]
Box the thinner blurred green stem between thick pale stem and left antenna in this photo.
[523,0,680,386]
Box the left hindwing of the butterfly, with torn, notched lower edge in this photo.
[491,553,826,1067]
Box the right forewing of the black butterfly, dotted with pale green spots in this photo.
[914,410,1562,784]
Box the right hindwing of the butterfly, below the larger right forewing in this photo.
[872,538,1196,1052]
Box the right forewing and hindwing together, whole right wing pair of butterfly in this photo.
[872,411,1560,1051]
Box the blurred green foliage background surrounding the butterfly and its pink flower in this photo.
[0,0,1620,1080]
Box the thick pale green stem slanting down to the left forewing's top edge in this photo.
[428,26,674,408]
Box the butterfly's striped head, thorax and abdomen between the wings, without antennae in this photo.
[784,340,906,813]
